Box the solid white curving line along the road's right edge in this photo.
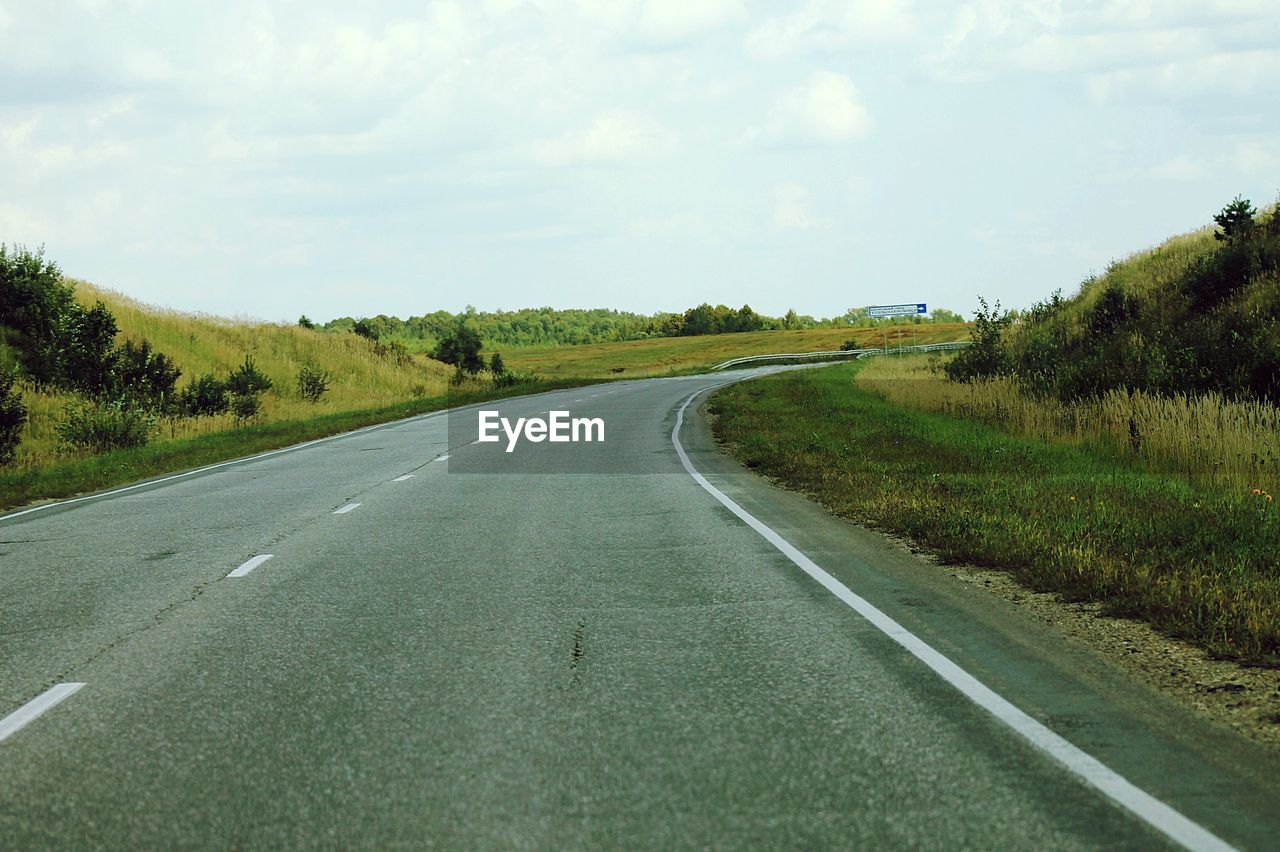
[671,383,1234,851]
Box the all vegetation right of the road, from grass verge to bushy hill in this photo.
[714,198,1280,664]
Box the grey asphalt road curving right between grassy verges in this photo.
[0,368,1280,849]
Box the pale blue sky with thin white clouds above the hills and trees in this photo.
[0,0,1280,321]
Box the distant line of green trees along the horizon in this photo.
[314,303,964,352]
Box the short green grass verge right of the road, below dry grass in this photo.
[712,365,1280,665]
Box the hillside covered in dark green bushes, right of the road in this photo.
[1008,198,1280,403]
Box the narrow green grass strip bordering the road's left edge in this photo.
[0,379,598,510]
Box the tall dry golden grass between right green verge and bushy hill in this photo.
[854,357,1280,494]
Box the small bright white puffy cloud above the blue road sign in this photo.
[742,72,873,145]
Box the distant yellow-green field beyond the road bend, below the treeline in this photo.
[502,322,969,379]
